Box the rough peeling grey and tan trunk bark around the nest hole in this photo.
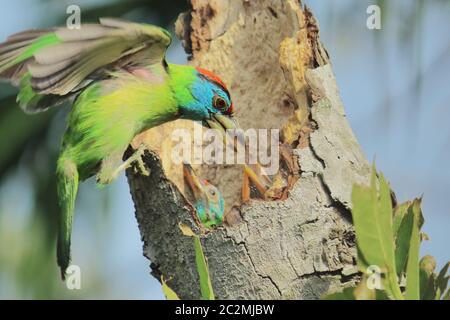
[127,0,370,299]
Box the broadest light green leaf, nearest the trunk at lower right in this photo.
[352,166,403,299]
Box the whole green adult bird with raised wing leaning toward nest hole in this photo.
[0,18,256,278]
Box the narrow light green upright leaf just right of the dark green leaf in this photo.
[405,199,423,300]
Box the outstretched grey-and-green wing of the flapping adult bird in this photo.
[0,18,171,112]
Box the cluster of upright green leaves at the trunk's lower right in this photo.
[326,167,450,300]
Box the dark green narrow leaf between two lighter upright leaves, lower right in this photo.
[395,210,414,276]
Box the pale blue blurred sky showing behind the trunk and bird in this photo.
[0,0,450,299]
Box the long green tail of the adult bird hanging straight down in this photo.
[56,154,78,280]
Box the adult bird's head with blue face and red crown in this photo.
[179,68,236,130]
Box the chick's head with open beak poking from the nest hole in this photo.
[183,164,225,228]
